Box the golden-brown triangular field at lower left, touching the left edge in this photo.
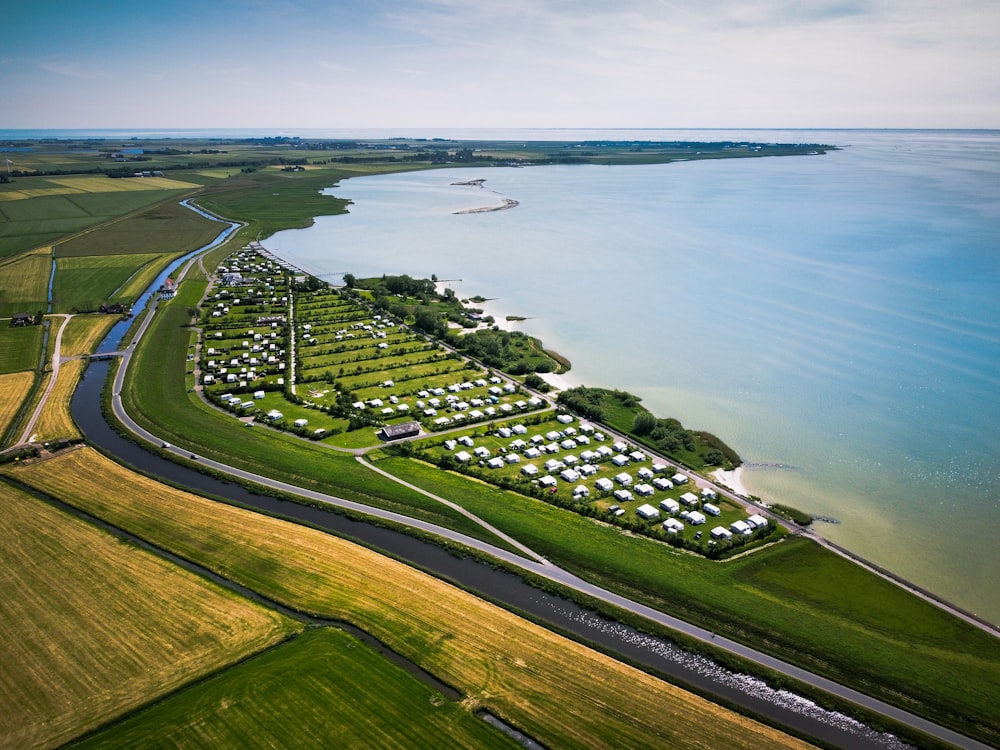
[0,483,300,748]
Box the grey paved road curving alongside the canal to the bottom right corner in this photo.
[105,253,988,750]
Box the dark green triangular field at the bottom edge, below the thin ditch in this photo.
[78,628,519,748]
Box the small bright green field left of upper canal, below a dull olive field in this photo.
[52,253,161,312]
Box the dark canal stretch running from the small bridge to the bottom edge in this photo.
[71,362,905,748]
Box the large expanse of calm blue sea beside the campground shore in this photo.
[267,131,1000,622]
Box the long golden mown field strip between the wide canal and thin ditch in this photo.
[5,449,806,748]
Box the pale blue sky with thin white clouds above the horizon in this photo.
[0,0,1000,129]
